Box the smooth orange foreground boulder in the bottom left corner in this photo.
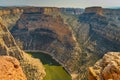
[0,56,27,80]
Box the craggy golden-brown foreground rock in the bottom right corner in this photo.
[88,52,120,80]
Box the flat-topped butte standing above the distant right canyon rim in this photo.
[85,6,103,15]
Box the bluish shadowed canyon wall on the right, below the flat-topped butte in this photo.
[63,6,120,80]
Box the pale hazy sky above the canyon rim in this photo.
[0,0,120,8]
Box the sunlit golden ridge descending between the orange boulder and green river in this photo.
[0,20,45,80]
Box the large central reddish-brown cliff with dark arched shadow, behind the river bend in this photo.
[11,8,79,76]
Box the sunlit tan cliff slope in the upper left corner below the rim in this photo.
[0,8,23,30]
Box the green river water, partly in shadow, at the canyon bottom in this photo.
[29,52,72,80]
